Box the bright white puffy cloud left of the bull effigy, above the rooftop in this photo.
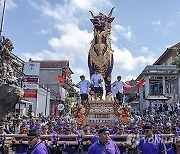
[23,24,93,64]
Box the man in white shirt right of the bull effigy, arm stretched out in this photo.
[111,76,131,103]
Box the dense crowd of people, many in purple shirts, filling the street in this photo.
[0,106,180,154]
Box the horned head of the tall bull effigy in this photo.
[89,7,115,31]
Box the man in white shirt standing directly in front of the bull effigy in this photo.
[91,69,104,99]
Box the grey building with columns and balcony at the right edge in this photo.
[136,43,180,112]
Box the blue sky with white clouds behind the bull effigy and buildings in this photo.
[0,0,180,83]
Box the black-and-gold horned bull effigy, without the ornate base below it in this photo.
[88,8,114,95]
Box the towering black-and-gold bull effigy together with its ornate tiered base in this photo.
[73,8,132,127]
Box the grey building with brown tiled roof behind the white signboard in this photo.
[36,60,73,116]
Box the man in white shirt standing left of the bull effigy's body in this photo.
[76,75,91,102]
